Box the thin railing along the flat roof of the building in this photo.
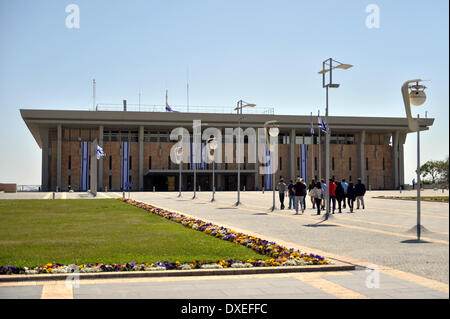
[96,103,274,115]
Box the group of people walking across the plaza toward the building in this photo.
[277,177,366,215]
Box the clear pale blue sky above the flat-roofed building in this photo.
[0,0,449,184]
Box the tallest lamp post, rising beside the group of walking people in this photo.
[318,58,353,220]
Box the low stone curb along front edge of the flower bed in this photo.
[0,262,355,283]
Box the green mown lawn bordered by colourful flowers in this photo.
[0,199,268,267]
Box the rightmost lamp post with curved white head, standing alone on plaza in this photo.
[402,79,427,241]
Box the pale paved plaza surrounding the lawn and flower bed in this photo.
[0,190,449,299]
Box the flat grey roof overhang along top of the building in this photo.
[20,109,434,147]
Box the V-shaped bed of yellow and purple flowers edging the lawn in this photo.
[0,198,330,275]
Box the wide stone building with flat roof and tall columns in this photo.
[20,109,434,191]
